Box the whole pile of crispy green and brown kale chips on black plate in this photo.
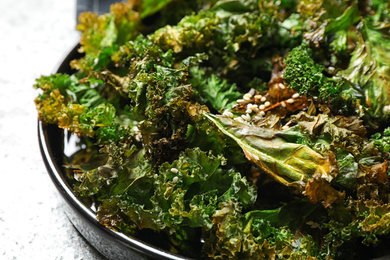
[35,0,390,259]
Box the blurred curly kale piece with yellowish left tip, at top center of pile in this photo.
[151,4,280,81]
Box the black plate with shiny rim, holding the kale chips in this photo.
[38,45,193,260]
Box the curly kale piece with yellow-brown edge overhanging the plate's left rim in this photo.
[34,74,126,137]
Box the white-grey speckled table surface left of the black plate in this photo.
[0,0,104,260]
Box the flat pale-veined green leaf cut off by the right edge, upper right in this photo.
[338,21,390,124]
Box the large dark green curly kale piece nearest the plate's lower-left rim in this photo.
[87,148,256,254]
